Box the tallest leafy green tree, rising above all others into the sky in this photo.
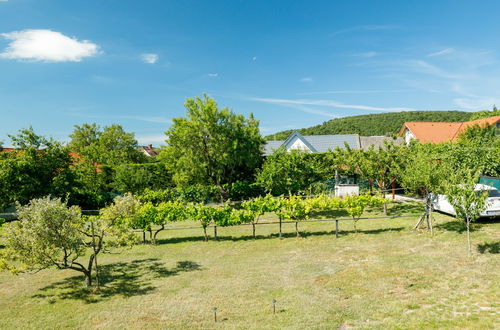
[161,95,264,200]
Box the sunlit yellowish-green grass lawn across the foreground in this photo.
[0,204,500,329]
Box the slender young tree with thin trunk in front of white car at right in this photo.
[446,170,488,254]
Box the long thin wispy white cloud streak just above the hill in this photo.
[249,97,413,112]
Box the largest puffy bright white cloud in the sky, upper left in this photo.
[0,30,99,62]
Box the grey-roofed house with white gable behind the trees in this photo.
[264,132,403,156]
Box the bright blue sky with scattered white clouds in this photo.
[0,0,500,146]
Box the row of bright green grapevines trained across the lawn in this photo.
[129,194,387,242]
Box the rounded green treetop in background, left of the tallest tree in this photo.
[69,124,145,165]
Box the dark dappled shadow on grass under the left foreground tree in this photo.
[33,258,202,303]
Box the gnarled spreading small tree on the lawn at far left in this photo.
[0,197,138,287]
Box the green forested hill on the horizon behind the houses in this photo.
[266,111,474,140]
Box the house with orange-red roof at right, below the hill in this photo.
[398,116,500,143]
